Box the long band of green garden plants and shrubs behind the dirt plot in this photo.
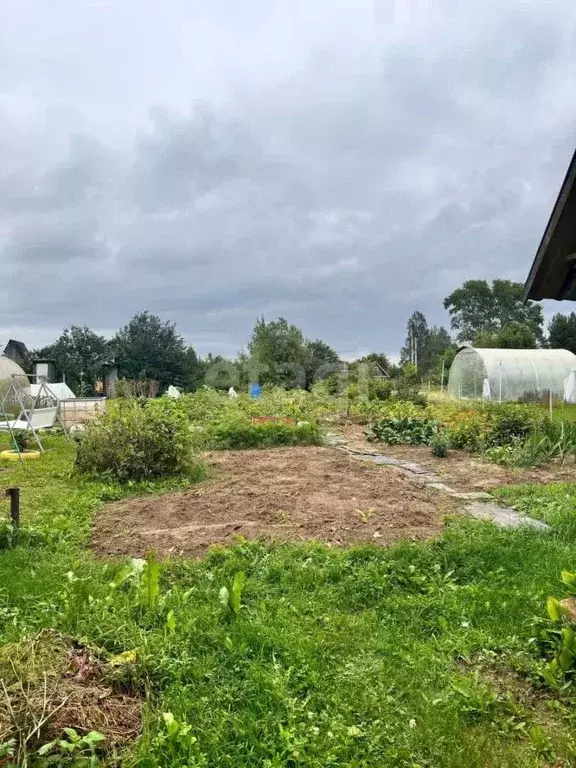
[77,376,576,468]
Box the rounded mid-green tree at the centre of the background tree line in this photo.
[248,317,308,389]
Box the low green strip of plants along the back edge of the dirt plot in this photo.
[207,422,322,450]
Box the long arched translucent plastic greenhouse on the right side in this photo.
[448,347,576,401]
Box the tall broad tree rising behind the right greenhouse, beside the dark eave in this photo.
[444,280,544,343]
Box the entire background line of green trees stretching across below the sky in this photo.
[31,280,576,396]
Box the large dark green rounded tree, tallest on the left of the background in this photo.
[111,312,191,391]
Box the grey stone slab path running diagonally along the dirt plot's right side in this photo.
[327,434,550,531]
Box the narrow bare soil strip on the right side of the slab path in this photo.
[338,425,576,492]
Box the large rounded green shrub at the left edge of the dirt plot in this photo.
[76,401,201,482]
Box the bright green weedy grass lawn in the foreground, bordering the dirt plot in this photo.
[0,438,576,768]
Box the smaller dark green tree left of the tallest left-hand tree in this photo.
[31,325,110,397]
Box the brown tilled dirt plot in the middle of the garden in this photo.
[93,448,457,556]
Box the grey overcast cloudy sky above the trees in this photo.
[0,0,576,356]
